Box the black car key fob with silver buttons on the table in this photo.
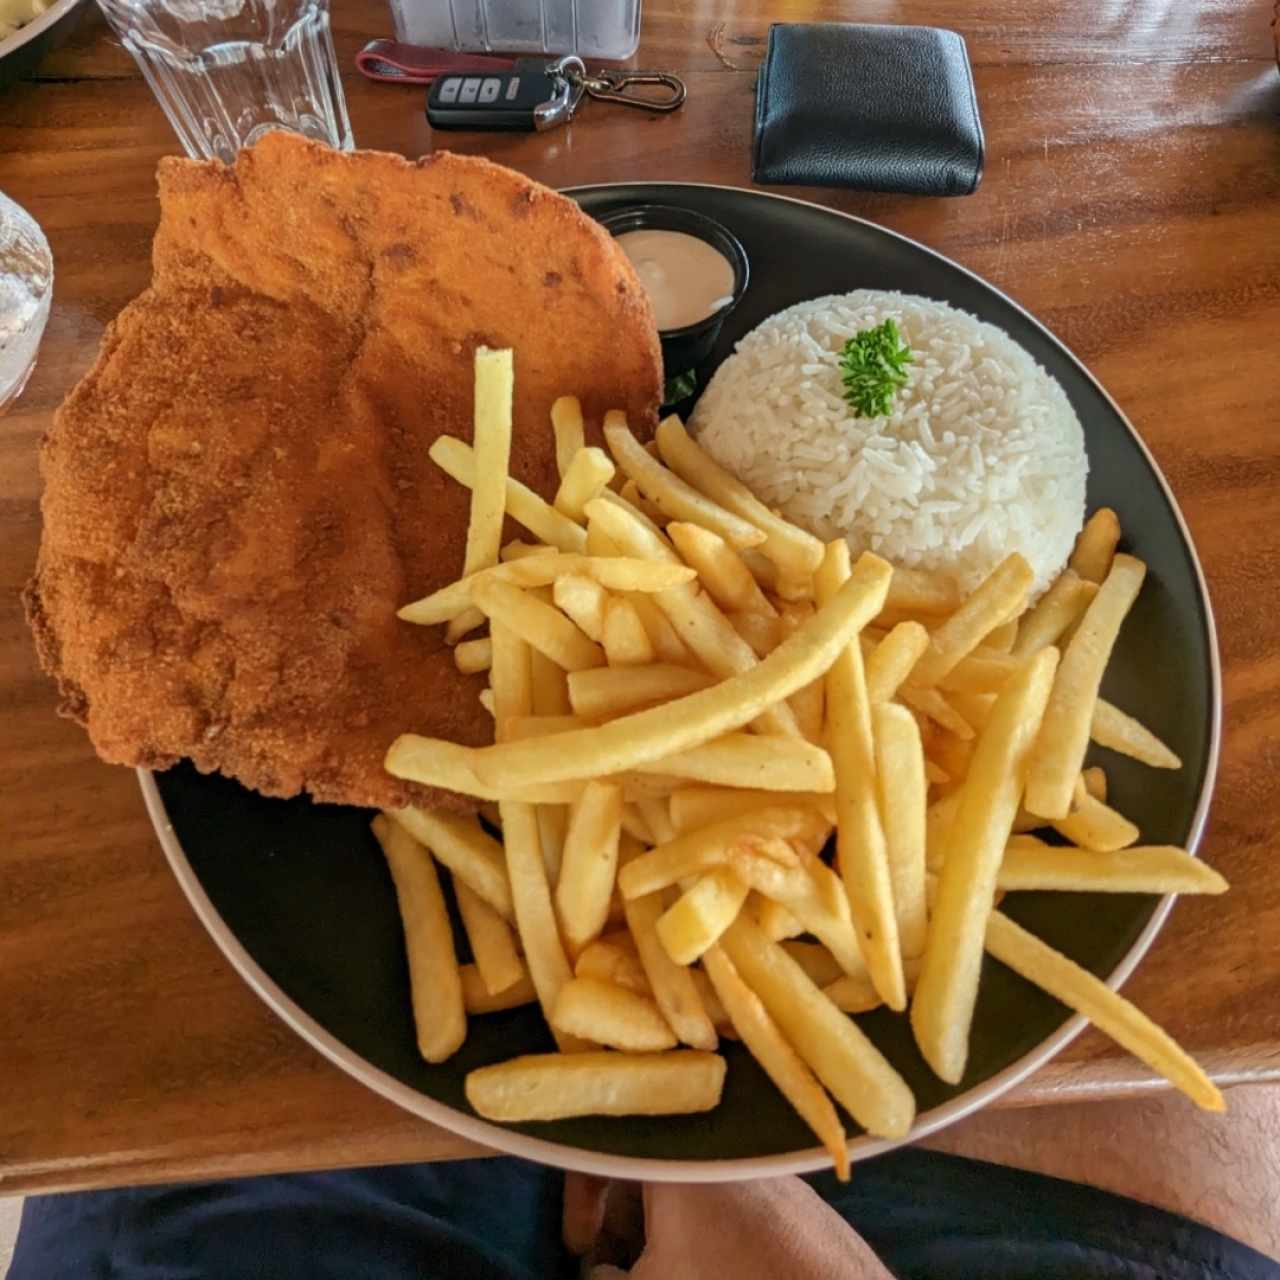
[426,58,582,133]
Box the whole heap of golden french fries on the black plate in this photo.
[376,353,1226,1176]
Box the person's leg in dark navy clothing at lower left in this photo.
[10,1160,573,1280]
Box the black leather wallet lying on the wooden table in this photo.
[753,22,983,196]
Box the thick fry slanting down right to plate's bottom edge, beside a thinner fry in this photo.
[721,915,915,1138]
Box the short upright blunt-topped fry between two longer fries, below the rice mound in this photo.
[872,703,928,959]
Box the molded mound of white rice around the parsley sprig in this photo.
[690,289,1089,594]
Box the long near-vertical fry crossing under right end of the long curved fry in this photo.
[814,539,906,1010]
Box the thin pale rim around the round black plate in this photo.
[137,183,1222,1183]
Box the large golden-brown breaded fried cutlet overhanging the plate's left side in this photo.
[26,133,662,808]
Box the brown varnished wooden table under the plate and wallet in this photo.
[0,0,1280,1193]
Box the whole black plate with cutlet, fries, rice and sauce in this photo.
[27,134,1226,1180]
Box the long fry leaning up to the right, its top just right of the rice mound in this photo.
[1025,556,1147,818]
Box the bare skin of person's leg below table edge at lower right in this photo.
[922,1084,1280,1258]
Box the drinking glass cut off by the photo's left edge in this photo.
[0,191,54,413]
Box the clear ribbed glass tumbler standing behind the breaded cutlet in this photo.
[99,0,353,161]
